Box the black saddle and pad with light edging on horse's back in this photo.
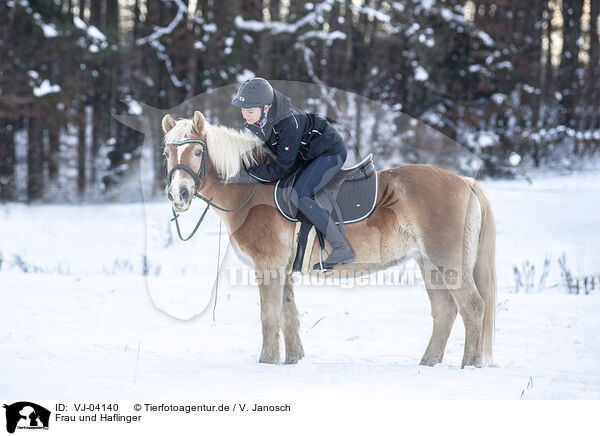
[273,154,378,224]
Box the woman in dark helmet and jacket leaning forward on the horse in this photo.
[231,77,355,269]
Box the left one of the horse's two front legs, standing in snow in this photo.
[256,270,283,363]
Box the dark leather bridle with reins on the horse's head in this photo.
[165,139,258,241]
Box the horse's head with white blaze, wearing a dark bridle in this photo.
[162,111,207,212]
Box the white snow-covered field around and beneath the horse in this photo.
[0,172,600,401]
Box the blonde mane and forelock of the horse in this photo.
[164,118,271,180]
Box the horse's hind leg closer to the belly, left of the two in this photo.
[419,262,458,366]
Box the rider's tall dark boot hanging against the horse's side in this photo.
[298,197,355,269]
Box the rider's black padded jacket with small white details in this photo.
[244,91,346,182]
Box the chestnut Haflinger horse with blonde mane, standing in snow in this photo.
[162,111,496,367]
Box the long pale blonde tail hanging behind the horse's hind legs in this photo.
[472,182,496,366]
